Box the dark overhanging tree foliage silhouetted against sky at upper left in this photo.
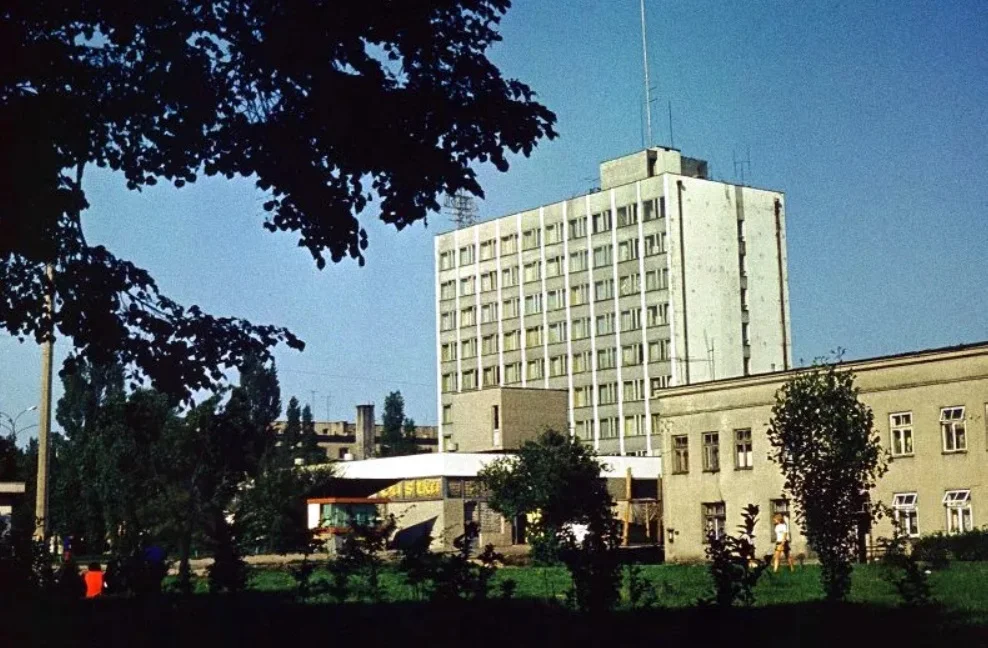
[0,0,555,398]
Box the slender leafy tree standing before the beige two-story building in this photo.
[768,364,888,601]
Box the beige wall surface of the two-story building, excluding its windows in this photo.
[660,345,988,560]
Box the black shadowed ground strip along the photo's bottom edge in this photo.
[0,593,988,648]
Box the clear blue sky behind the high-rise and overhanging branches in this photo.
[0,0,988,436]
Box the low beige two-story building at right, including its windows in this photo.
[655,343,988,560]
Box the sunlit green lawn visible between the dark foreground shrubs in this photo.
[233,562,988,623]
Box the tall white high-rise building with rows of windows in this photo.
[435,147,791,455]
